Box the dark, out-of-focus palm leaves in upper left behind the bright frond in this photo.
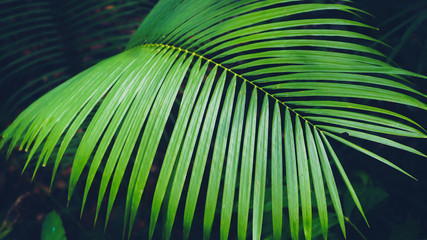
[0,0,153,124]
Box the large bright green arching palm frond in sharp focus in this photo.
[0,0,426,239]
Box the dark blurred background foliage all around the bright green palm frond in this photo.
[0,0,427,240]
